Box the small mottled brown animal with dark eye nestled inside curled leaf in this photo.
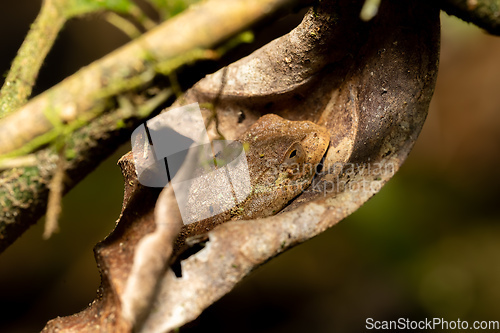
[175,114,330,252]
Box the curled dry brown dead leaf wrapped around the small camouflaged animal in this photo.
[44,0,439,332]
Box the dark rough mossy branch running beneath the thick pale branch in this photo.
[0,104,154,252]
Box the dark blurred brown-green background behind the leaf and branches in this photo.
[0,0,500,332]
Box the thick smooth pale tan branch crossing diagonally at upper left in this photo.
[0,0,304,155]
